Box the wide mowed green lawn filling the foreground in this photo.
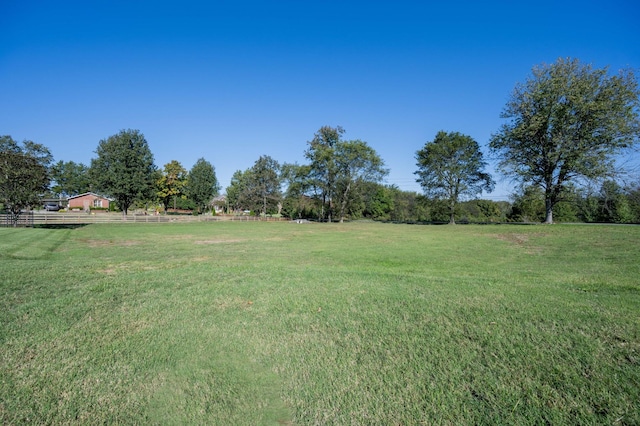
[0,222,640,425]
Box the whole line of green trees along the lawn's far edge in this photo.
[0,58,640,223]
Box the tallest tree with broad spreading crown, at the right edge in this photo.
[490,58,640,223]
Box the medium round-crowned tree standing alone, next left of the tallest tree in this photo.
[415,131,494,224]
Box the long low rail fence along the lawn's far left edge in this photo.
[0,212,288,227]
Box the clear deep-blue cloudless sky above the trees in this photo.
[0,0,640,199]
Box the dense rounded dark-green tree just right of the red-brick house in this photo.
[89,129,156,215]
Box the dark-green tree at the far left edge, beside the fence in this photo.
[0,136,53,226]
